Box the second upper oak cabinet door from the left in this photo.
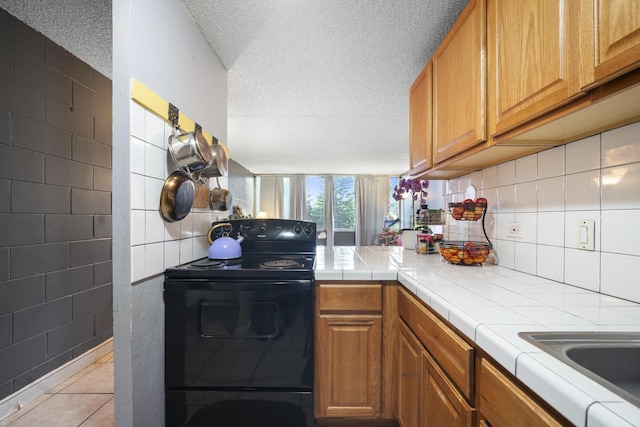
[432,0,486,163]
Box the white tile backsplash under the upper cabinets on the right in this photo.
[444,122,640,302]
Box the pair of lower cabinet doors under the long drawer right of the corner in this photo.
[396,320,474,427]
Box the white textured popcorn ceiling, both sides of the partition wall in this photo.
[0,0,467,175]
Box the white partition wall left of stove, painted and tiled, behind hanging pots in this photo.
[112,0,228,427]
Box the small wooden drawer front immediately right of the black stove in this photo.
[318,284,382,313]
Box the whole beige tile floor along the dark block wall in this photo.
[0,352,114,427]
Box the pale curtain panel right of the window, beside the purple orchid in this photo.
[355,176,390,246]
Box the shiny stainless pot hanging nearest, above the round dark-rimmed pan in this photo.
[169,128,213,183]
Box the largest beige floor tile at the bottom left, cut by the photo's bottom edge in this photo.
[4,394,113,427]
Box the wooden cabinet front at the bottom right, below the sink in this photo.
[477,358,563,427]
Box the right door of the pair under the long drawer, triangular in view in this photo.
[421,352,474,427]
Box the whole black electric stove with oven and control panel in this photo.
[164,220,315,427]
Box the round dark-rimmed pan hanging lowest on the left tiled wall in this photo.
[160,171,196,222]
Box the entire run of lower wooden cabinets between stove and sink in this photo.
[315,282,569,427]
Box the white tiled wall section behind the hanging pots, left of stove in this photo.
[130,101,221,282]
